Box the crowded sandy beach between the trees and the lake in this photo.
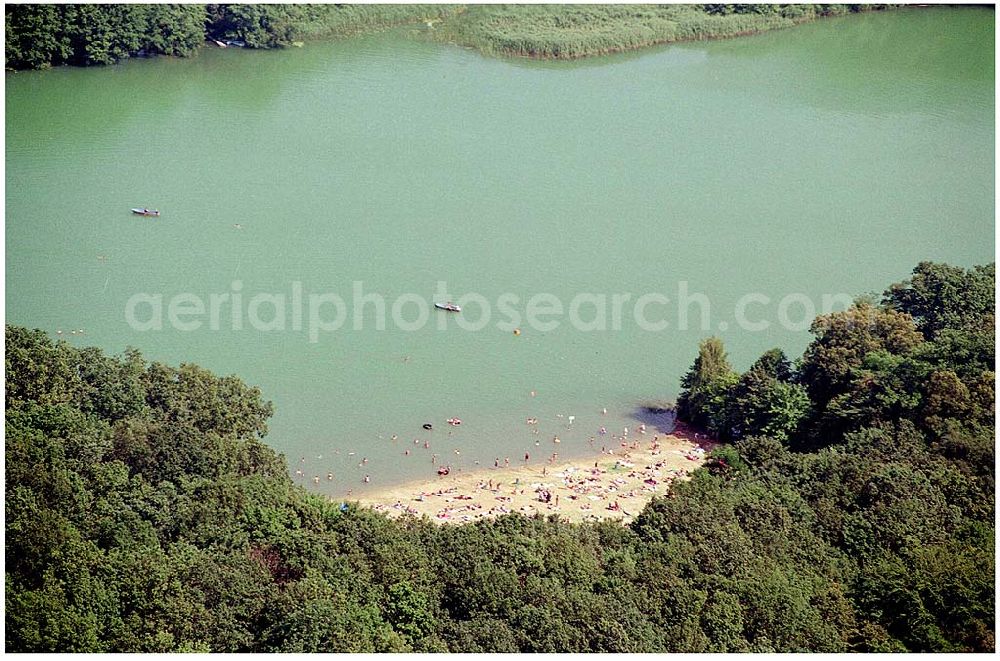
[358,428,714,523]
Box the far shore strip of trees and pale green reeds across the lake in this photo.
[5,4,885,69]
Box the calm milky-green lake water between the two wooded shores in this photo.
[5,8,995,494]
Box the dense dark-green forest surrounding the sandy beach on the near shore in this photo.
[5,263,995,652]
